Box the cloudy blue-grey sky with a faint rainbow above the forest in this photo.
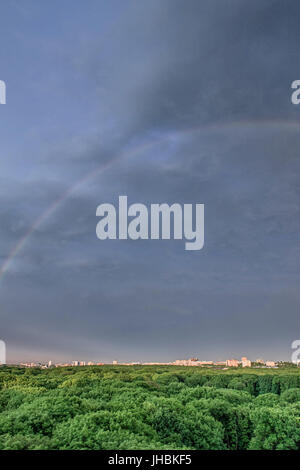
[0,0,300,362]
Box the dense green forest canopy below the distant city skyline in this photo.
[0,365,300,450]
